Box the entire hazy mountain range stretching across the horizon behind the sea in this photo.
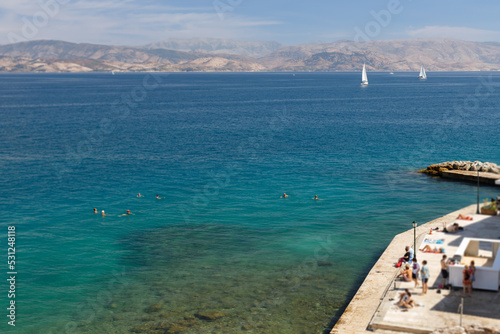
[0,38,500,72]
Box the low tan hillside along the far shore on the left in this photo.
[0,40,265,72]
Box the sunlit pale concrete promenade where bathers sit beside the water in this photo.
[331,205,500,334]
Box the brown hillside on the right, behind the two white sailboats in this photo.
[261,39,500,71]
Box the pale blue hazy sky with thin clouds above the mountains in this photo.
[0,0,500,45]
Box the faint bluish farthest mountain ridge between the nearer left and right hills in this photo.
[144,38,284,58]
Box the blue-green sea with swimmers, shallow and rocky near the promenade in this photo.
[0,72,500,334]
